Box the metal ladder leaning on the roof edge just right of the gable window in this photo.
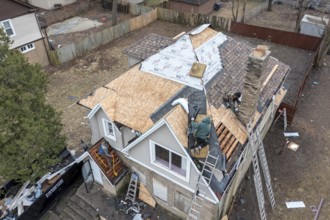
[187,152,219,220]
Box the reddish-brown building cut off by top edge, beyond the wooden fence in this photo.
[168,0,216,14]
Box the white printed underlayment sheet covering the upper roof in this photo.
[141,24,227,90]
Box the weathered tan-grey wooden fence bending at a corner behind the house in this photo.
[48,4,231,64]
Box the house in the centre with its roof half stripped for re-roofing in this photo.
[79,25,290,219]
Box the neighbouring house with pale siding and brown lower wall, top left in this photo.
[0,0,49,66]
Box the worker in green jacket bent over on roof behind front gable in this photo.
[191,117,211,152]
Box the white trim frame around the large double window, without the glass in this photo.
[149,140,190,182]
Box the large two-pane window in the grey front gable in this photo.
[152,143,187,177]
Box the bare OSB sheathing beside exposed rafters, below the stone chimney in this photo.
[211,106,247,144]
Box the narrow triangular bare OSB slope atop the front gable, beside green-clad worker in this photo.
[165,105,188,147]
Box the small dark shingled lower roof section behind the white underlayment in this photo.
[123,33,174,60]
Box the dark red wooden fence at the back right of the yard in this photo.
[230,22,321,52]
